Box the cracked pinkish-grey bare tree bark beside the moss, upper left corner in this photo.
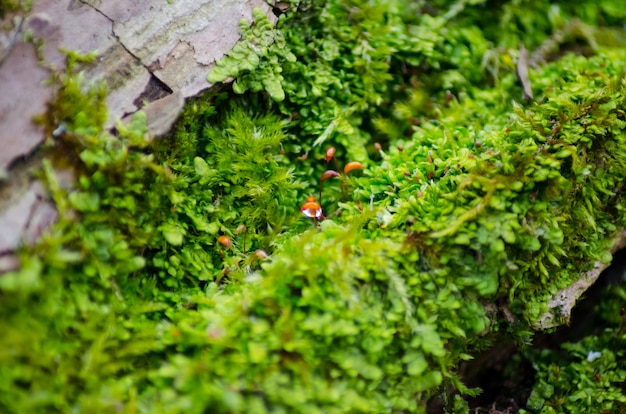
[0,0,275,274]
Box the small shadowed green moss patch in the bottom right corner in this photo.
[518,283,626,413]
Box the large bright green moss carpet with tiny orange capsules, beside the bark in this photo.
[0,1,626,413]
